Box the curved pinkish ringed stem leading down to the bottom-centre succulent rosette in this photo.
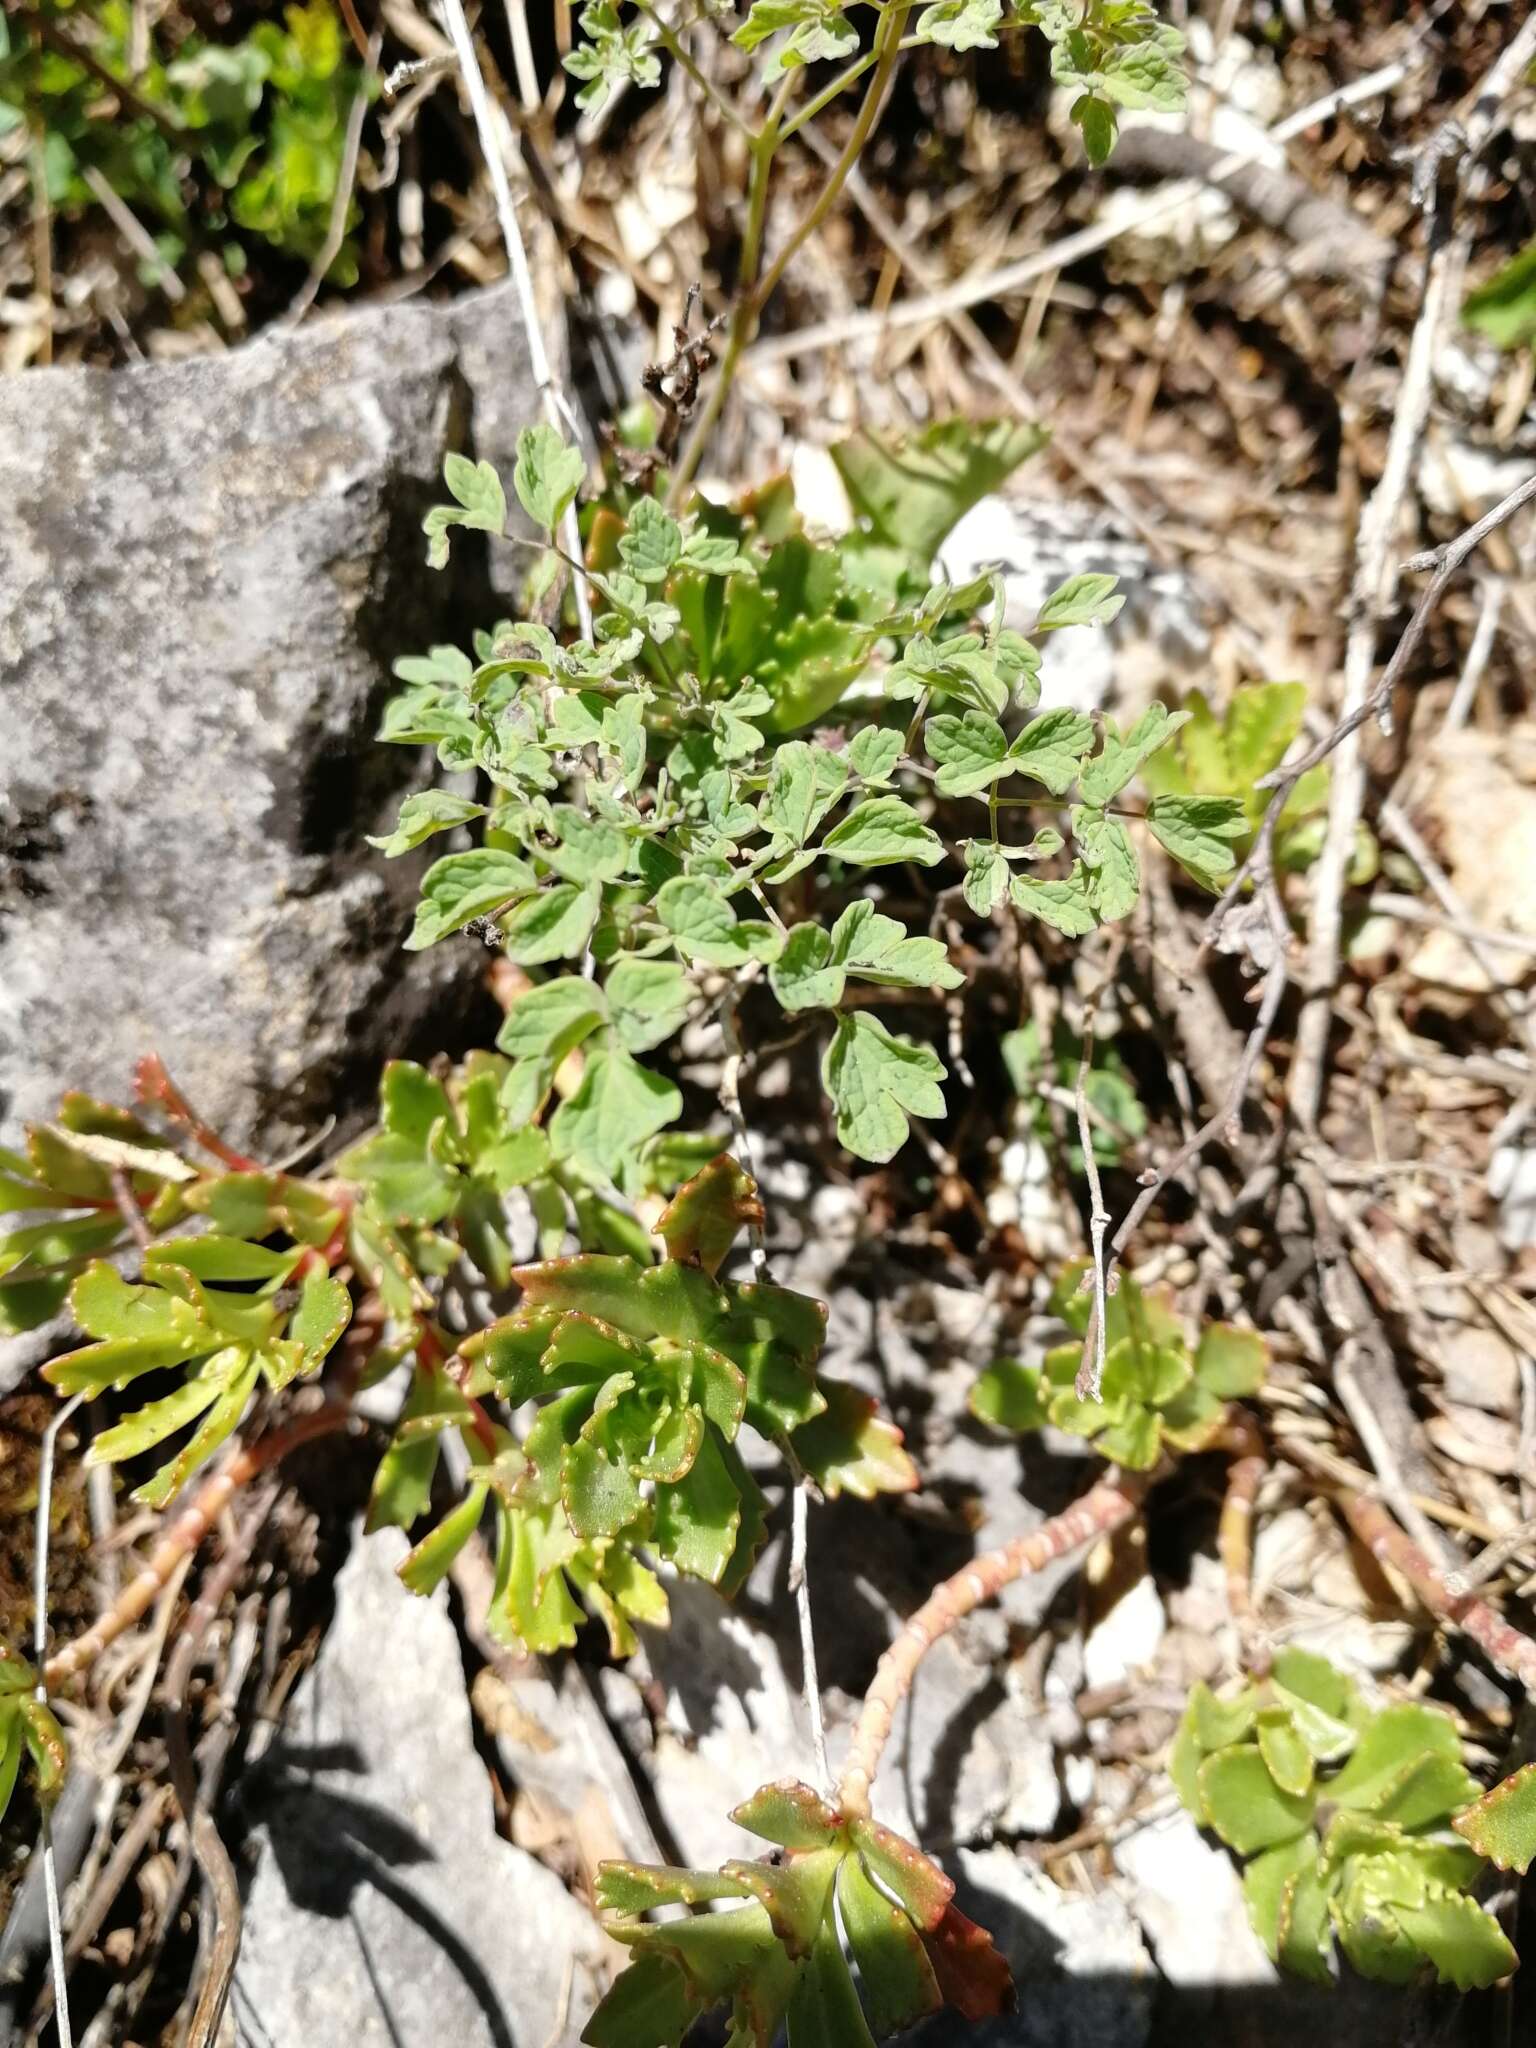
[838,1470,1153,1815]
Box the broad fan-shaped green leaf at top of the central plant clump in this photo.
[831,420,1051,573]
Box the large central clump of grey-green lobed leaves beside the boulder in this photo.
[381,426,1243,1188]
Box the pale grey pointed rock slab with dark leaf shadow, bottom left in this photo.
[233,1530,604,2048]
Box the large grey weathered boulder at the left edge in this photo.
[0,289,537,1153]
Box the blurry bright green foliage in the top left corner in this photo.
[0,0,376,285]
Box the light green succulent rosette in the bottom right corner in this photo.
[1167,1649,1516,1991]
